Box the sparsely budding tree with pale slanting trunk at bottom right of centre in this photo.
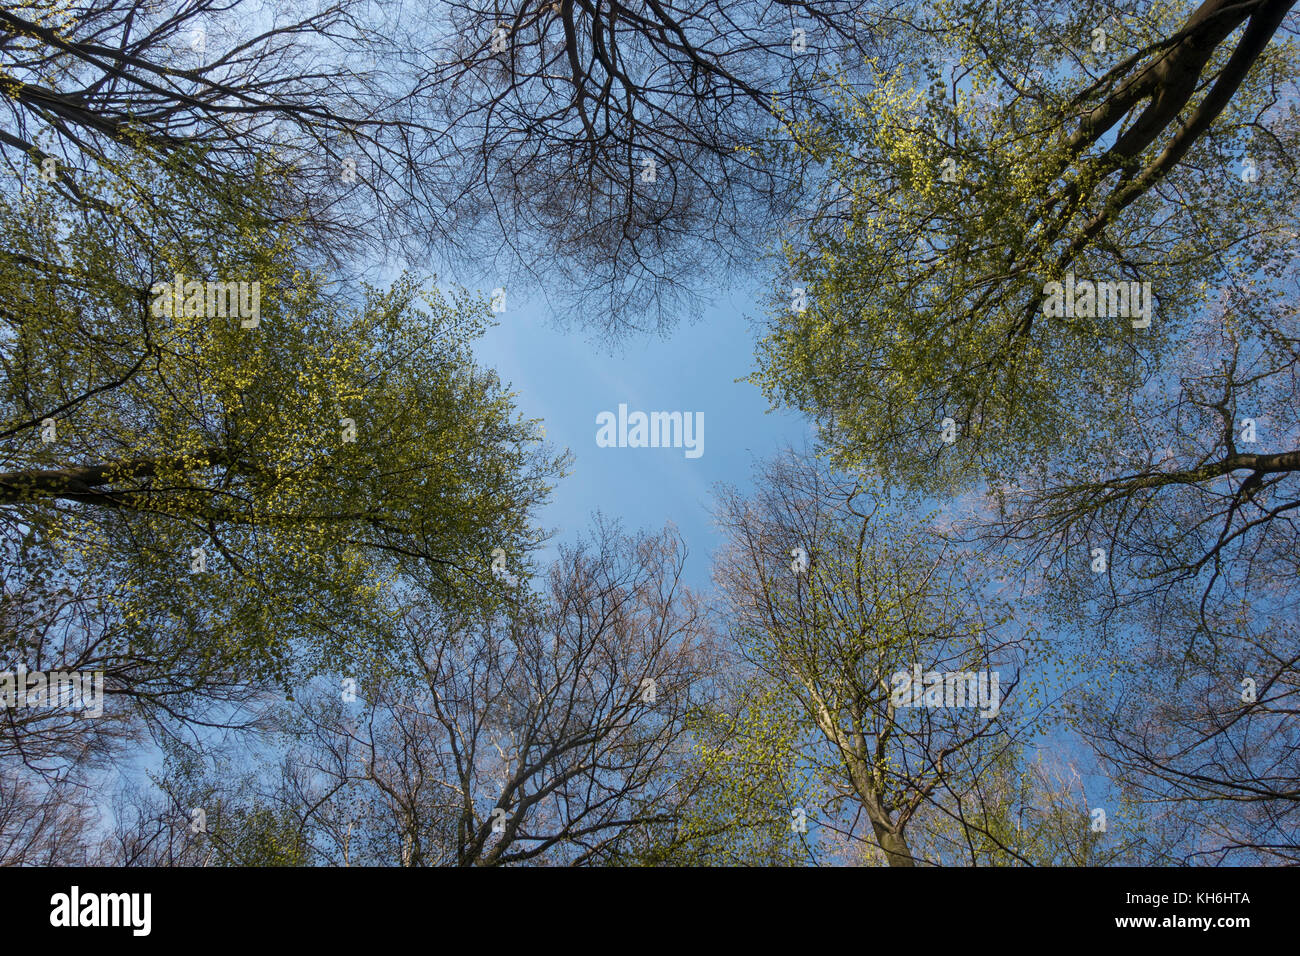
[716,455,1040,866]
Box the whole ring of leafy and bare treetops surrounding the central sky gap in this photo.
[0,0,1300,866]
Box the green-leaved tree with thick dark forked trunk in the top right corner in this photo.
[754,0,1297,489]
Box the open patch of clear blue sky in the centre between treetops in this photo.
[475,286,813,587]
